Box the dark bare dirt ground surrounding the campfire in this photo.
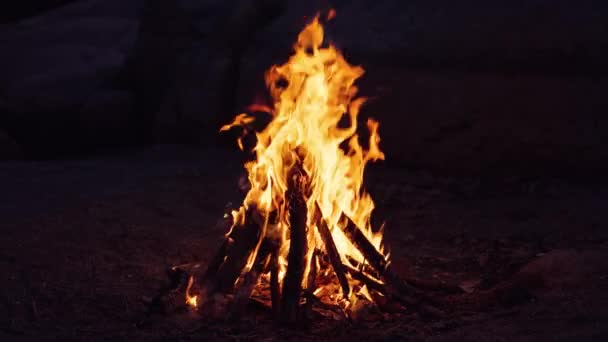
[0,146,608,341]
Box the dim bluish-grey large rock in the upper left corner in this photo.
[0,0,143,156]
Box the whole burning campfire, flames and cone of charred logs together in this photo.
[151,9,441,323]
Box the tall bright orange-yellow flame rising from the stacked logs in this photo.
[221,12,388,304]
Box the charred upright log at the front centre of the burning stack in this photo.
[281,165,307,324]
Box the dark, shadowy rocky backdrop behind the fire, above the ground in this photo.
[0,0,608,175]
